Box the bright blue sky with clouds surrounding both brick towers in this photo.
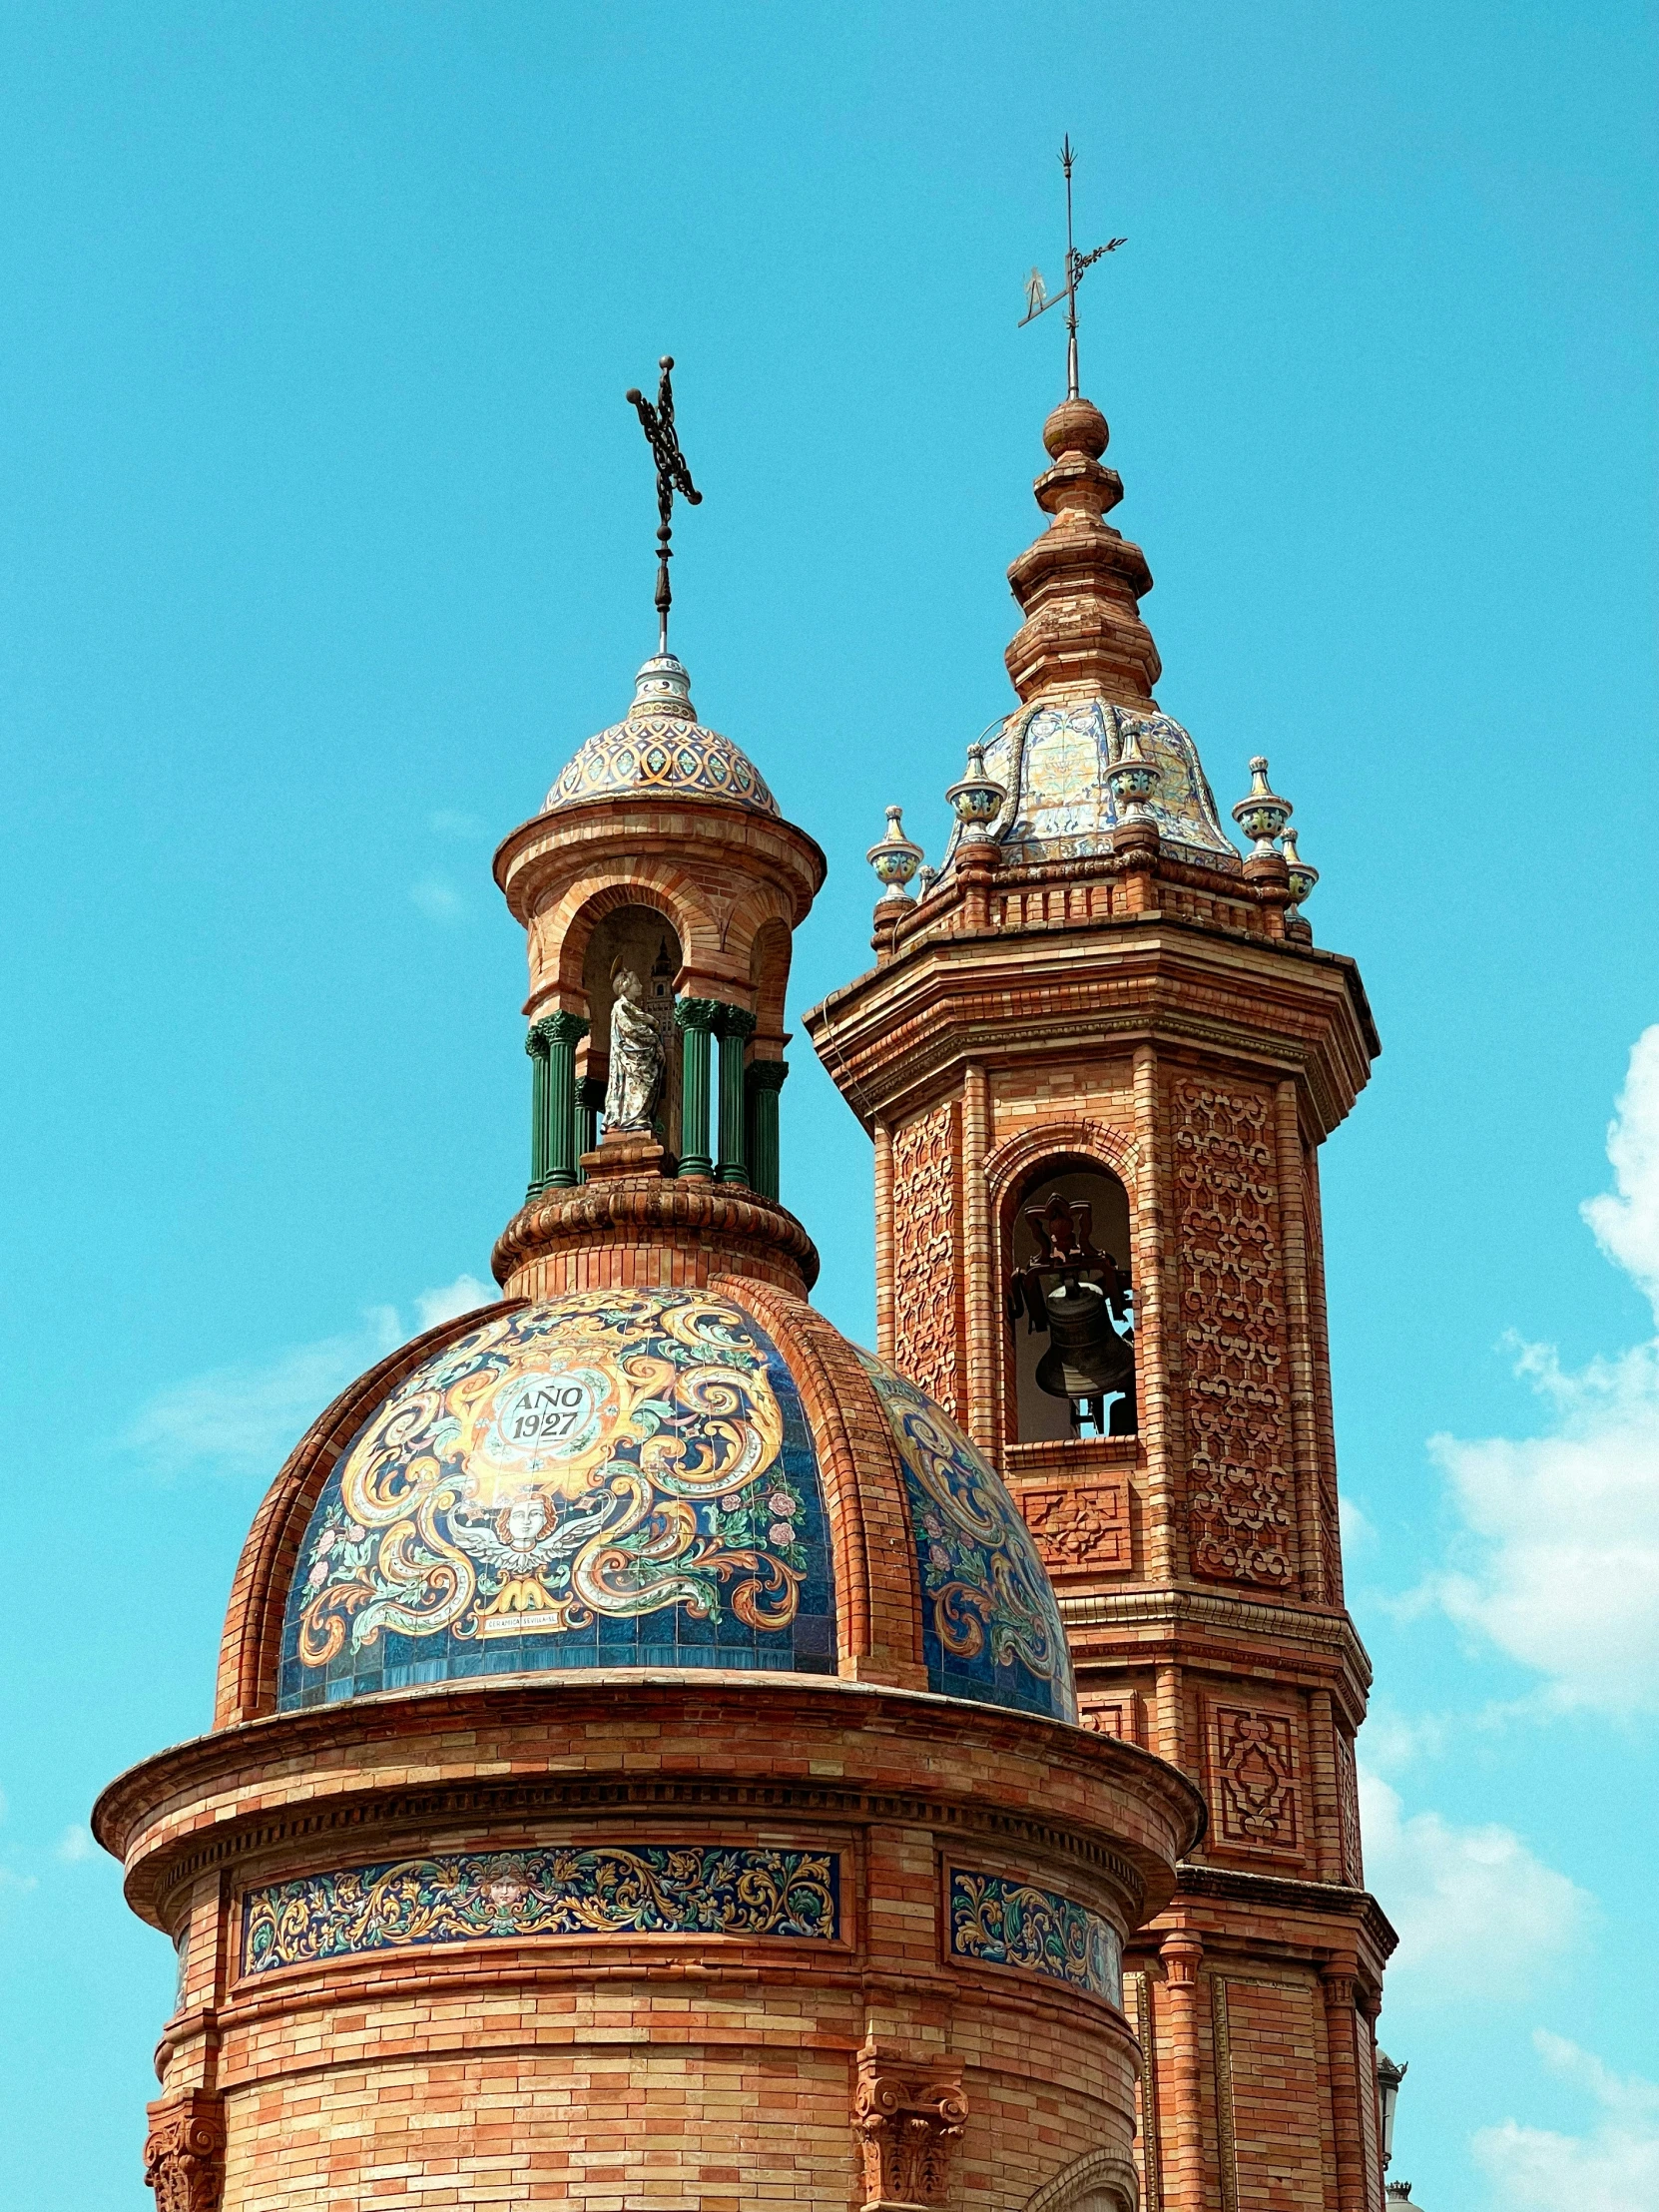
[0,0,1659,2212]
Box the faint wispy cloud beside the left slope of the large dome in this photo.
[124,1274,493,1477]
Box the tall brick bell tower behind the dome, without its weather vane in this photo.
[806,398,1393,2212]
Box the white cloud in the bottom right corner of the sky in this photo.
[1471,2028,1659,2212]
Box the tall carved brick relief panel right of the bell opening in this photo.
[1175,1082,1297,1588]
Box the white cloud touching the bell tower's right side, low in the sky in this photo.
[1361,1768,1595,2001]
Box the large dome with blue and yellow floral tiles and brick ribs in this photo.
[270,1277,1077,1721]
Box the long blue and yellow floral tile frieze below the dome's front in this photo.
[242,1843,840,1973]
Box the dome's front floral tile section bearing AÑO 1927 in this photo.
[278,1290,836,1710]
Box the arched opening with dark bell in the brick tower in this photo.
[1002,1159,1137,1444]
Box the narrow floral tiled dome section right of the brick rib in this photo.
[858,1352,1077,1721]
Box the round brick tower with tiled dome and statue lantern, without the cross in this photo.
[95,632,1204,2212]
